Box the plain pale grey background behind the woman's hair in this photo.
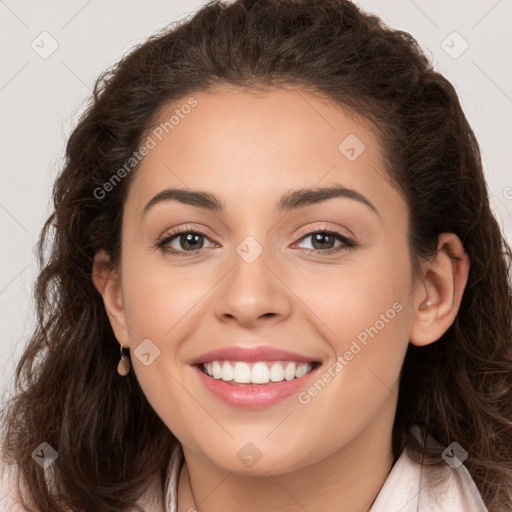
[0,0,512,400]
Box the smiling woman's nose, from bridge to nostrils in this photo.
[215,240,293,328]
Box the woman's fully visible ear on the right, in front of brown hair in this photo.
[409,233,470,346]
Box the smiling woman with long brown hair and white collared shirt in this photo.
[4,0,512,512]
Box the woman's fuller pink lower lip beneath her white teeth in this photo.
[193,365,318,408]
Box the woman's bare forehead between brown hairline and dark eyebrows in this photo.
[125,87,403,224]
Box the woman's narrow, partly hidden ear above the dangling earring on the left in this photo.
[92,249,130,347]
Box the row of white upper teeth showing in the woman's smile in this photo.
[199,361,313,384]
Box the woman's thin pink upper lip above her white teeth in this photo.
[190,346,318,365]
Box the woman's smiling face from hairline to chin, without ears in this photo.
[105,88,419,474]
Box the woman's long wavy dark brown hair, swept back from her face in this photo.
[3,0,512,512]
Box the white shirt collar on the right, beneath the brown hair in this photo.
[370,448,488,512]
